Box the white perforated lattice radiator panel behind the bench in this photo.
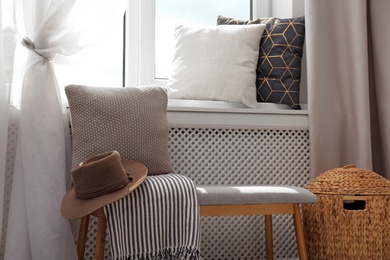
[169,128,309,260]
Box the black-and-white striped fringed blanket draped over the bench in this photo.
[105,174,201,260]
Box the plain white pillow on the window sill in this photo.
[167,24,265,108]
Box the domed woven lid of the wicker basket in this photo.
[305,164,390,195]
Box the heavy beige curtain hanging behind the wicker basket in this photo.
[305,0,390,178]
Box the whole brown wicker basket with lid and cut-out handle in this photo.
[302,165,390,260]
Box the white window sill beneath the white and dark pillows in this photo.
[167,99,309,130]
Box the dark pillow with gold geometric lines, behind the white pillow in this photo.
[217,16,305,109]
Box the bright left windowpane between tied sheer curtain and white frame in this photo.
[55,4,125,90]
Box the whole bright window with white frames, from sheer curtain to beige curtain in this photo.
[55,0,304,100]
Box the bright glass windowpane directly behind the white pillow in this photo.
[155,0,251,79]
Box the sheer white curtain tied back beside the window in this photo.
[0,0,125,260]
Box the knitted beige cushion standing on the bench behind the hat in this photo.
[65,85,172,174]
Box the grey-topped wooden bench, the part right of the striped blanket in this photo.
[196,185,317,259]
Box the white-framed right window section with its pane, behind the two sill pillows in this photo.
[125,0,304,89]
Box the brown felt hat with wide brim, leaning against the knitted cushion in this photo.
[61,151,148,219]
